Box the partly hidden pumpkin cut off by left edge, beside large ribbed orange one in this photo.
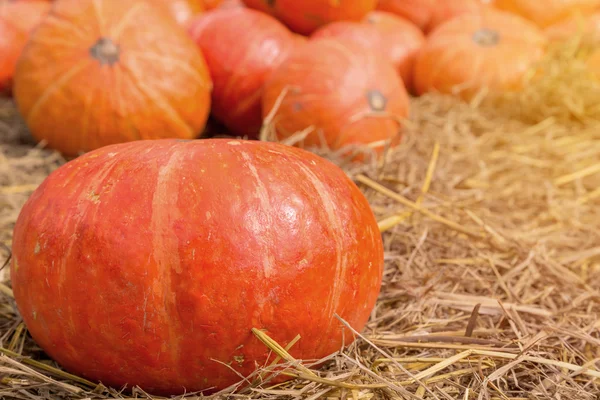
[0,0,50,93]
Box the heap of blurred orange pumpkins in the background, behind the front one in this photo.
[0,0,600,155]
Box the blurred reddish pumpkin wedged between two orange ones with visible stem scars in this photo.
[189,8,295,137]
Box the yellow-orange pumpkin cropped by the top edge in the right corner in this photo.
[493,0,600,28]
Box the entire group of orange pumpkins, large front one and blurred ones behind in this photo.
[0,0,600,395]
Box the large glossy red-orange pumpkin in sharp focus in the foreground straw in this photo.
[11,139,384,396]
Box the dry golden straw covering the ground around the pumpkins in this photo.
[0,39,600,400]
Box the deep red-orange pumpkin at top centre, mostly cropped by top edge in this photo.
[273,0,377,35]
